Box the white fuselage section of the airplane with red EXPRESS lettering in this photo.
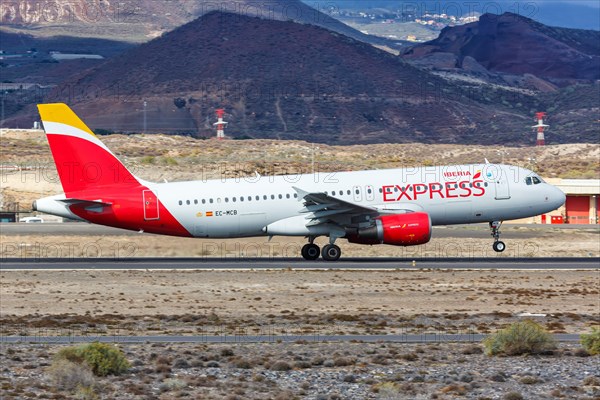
[148,164,564,238]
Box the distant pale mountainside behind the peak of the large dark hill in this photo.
[0,0,396,47]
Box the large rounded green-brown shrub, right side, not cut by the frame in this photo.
[483,321,556,356]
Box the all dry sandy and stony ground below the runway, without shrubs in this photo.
[0,269,600,400]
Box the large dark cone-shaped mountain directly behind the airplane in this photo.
[7,12,548,144]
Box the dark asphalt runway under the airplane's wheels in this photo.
[0,257,600,271]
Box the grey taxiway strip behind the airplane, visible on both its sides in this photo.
[0,222,600,239]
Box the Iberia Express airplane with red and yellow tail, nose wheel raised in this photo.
[33,103,565,261]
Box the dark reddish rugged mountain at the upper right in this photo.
[402,13,600,84]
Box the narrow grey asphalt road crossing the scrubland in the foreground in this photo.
[0,333,579,344]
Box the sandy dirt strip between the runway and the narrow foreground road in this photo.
[0,265,600,335]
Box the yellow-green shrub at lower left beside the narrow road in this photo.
[56,342,130,376]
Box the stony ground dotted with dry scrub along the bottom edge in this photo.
[0,342,600,400]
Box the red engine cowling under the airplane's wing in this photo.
[346,212,431,246]
